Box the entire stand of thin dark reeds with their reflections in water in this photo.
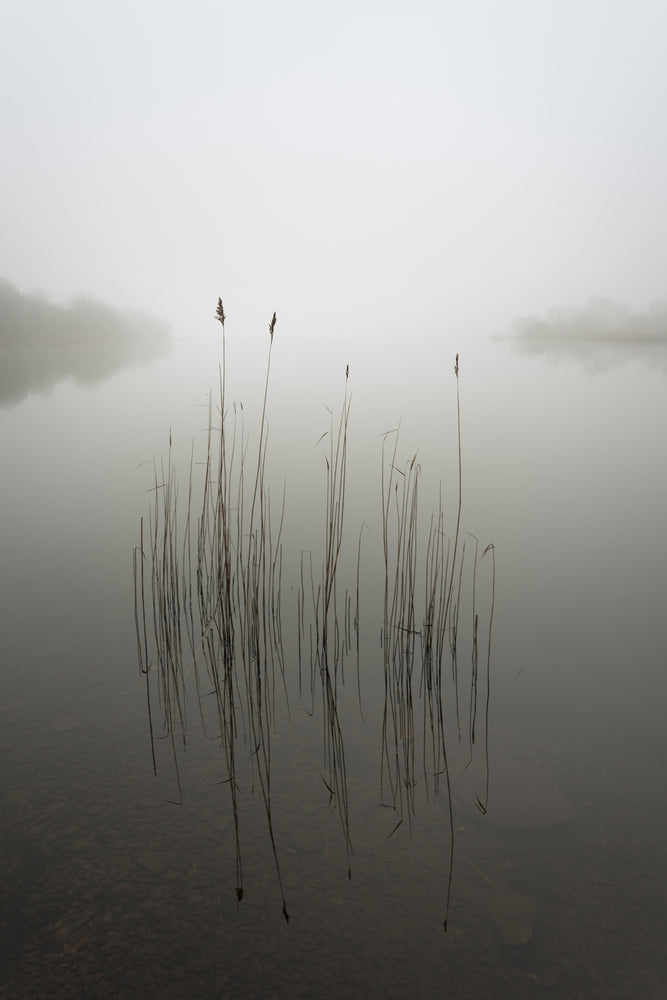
[133,299,495,929]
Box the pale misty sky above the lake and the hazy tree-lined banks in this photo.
[0,0,667,360]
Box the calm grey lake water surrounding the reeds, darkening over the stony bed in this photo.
[0,334,667,1000]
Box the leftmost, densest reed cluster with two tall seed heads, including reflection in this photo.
[134,299,289,919]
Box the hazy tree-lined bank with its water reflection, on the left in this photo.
[0,279,170,406]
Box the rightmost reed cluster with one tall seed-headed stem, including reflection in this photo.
[381,354,495,930]
